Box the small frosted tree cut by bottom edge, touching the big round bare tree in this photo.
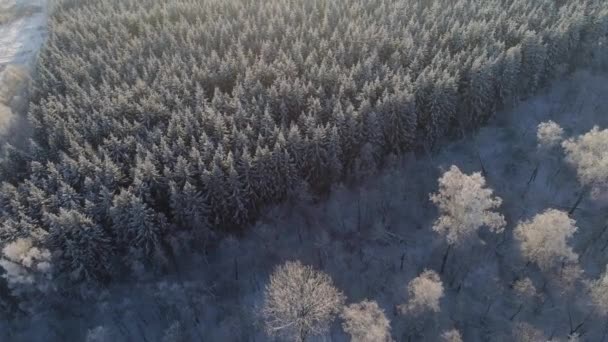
[341,300,391,342]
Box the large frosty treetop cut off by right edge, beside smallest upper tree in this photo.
[562,126,608,194]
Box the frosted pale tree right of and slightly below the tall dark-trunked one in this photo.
[514,209,578,271]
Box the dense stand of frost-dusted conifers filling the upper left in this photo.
[0,0,608,281]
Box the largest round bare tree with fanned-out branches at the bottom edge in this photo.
[262,261,345,342]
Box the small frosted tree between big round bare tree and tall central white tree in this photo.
[401,270,443,314]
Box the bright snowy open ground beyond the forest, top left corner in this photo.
[0,0,47,138]
